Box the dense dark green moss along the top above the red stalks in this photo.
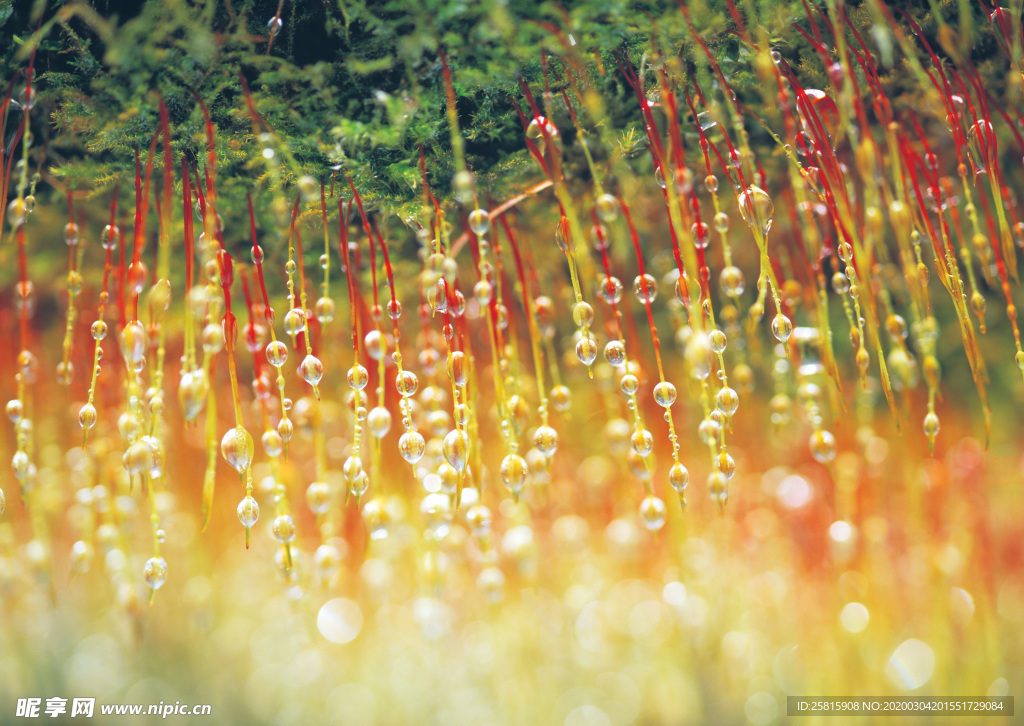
[0,0,1005,226]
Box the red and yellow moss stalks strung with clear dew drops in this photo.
[0,1,1024,593]
